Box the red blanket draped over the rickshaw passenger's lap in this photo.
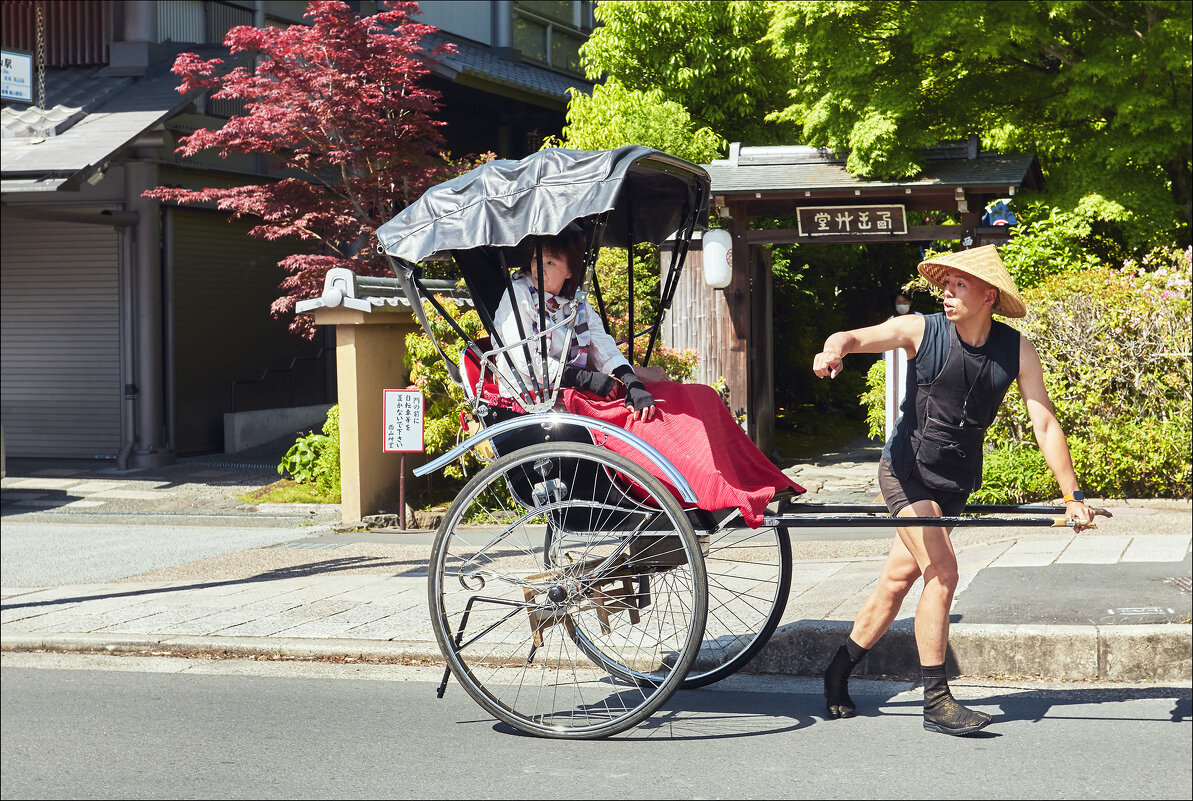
[563,381,804,529]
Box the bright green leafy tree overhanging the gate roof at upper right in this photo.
[772,0,1193,241]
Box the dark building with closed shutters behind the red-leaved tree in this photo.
[0,0,593,468]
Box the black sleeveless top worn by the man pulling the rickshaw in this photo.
[883,313,1019,493]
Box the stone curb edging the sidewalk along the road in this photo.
[7,621,1193,682]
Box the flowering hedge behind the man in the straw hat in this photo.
[861,247,1193,503]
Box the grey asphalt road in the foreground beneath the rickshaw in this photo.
[0,654,1193,799]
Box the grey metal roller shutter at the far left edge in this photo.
[0,209,120,458]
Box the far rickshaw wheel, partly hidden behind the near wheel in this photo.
[684,526,792,689]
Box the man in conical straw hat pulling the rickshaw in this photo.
[812,245,1094,735]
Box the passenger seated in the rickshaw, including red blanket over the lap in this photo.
[493,232,804,528]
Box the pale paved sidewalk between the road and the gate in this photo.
[0,444,1193,682]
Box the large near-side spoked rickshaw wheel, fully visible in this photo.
[428,443,707,738]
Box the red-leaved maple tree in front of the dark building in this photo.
[146,0,481,338]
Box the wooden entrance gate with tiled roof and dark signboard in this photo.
[662,137,1043,452]
